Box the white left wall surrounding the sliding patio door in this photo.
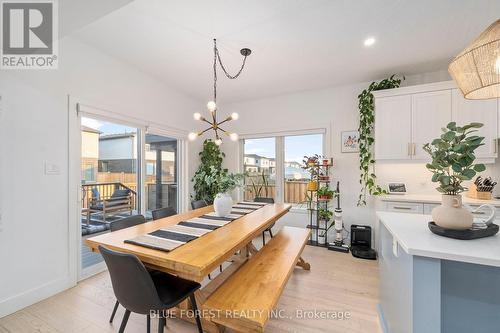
[0,38,199,317]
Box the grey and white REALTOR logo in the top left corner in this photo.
[0,0,58,69]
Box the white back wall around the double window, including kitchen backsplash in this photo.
[207,71,499,240]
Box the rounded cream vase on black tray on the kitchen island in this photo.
[432,194,474,230]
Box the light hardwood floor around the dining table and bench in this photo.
[0,246,381,333]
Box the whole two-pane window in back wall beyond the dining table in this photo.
[243,133,324,204]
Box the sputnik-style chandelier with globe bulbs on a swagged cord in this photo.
[188,39,252,146]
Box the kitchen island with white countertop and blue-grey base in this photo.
[377,212,500,333]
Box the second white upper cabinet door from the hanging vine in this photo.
[411,90,451,160]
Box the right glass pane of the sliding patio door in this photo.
[144,134,177,216]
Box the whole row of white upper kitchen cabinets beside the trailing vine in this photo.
[373,81,500,163]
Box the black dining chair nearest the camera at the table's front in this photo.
[99,246,203,333]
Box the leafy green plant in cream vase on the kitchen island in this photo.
[423,122,486,230]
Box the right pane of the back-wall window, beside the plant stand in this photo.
[283,134,323,204]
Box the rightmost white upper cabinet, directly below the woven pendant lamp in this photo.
[452,89,498,159]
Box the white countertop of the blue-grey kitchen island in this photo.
[377,212,500,267]
